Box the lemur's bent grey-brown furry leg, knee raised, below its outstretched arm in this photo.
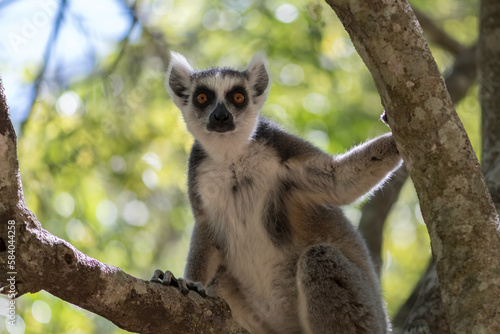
[297,244,387,334]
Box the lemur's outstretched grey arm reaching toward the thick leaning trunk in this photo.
[287,133,401,205]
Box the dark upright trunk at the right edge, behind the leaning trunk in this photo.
[479,0,500,208]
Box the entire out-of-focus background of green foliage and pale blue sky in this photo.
[0,0,480,334]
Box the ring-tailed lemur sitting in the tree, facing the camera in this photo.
[152,53,400,334]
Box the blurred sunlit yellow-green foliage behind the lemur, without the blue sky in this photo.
[0,0,479,333]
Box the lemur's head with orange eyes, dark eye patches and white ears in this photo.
[166,52,270,159]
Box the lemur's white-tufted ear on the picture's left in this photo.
[165,51,194,107]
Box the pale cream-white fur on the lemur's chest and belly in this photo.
[198,142,283,298]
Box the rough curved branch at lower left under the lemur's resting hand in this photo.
[0,76,247,333]
